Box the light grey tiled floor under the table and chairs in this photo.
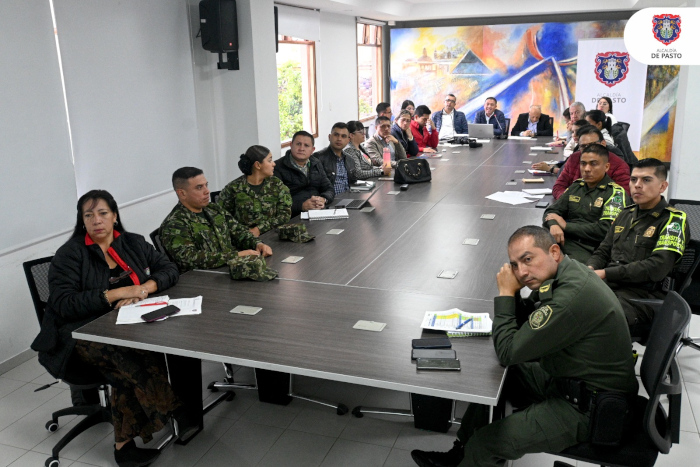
[0,316,700,467]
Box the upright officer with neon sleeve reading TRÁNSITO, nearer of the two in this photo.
[587,158,690,326]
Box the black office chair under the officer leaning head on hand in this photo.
[554,292,691,467]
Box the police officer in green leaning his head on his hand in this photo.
[411,226,638,467]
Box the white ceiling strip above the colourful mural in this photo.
[280,0,686,21]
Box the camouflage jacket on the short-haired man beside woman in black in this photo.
[160,203,260,272]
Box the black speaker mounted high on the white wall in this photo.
[199,0,238,53]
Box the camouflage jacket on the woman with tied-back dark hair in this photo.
[217,175,292,233]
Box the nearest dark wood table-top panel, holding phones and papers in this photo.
[74,271,505,405]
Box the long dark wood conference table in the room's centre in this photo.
[73,138,561,436]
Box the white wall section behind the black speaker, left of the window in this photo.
[188,0,280,190]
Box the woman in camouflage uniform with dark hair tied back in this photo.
[217,145,292,237]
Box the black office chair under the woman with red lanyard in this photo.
[23,256,112,467]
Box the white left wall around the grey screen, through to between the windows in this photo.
[0,0,357,368]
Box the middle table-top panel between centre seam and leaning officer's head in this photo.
[350,202,544,300]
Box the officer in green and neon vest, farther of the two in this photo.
[543,144,631,263]
